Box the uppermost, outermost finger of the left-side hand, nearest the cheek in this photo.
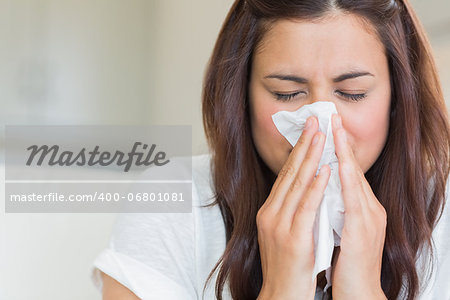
[266,117,319,212]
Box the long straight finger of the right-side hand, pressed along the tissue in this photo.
[332,115,367,214]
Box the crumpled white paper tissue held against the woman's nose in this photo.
[272,101,344,290]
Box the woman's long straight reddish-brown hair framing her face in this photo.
[202,0,450,300]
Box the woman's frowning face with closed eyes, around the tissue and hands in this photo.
[249,14,391,174]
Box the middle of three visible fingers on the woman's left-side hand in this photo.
[280,132,325,225]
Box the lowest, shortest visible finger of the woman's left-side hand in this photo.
[291,165,331,236]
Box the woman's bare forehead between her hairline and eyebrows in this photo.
[253,13,385,73]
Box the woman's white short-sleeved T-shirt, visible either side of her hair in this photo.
[92,154,450,300]
